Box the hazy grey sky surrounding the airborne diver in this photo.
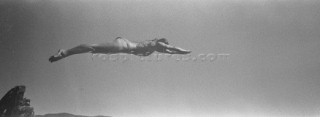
[0,0,320,117]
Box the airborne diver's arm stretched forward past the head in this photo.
[159,42,191,54]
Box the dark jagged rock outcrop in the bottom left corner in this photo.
[0,86,34,117]
